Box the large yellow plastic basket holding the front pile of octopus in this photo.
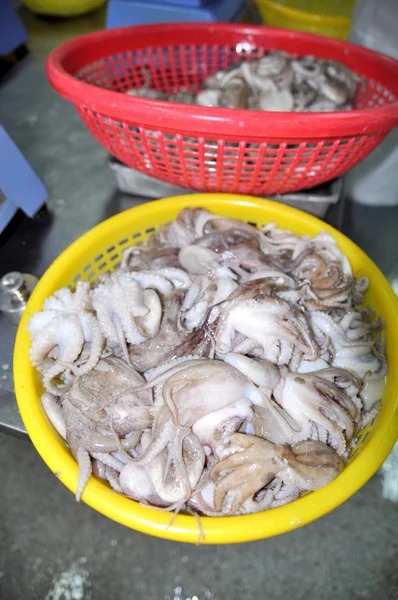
[14,194,398,544]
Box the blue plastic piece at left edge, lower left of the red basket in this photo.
[0,125,48,233]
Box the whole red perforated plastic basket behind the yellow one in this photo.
[47,23,398,195]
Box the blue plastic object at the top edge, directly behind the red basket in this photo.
[106,0,246,29]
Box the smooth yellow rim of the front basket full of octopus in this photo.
[14,194,398,544]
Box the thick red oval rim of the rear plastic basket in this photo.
[46,23,398,140]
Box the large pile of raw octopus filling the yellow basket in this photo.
[28,208,387,516]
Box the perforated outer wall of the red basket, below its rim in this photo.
[80,104,382,195]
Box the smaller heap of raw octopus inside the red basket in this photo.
[127,51,361,112]
